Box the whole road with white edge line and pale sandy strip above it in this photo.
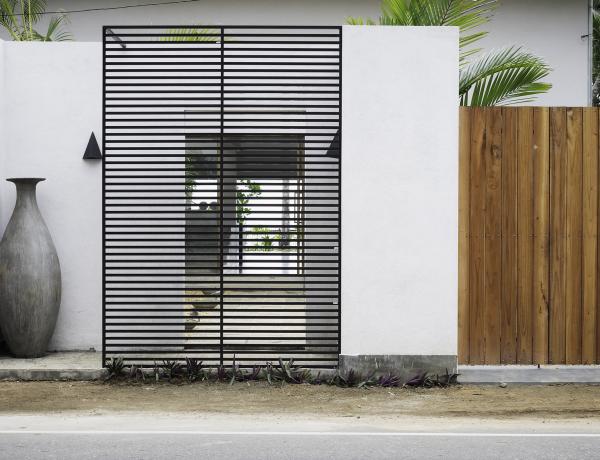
[0,414,600,460]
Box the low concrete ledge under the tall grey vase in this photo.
[0,351,106,380]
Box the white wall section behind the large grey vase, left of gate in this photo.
[0,42,102,349]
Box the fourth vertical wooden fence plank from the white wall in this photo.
[500,107,518,364]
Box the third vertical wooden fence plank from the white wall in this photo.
[484,107,502,364]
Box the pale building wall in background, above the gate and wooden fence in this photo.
[0,0,589,106]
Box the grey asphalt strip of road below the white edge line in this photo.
[0,432,600,460]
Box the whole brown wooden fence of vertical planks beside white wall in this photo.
[458,107,600,364]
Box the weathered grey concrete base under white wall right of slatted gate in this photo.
[340,355,457,381]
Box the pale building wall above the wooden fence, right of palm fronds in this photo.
[478,0,591,106]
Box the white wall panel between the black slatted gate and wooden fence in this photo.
[342,26,458,355]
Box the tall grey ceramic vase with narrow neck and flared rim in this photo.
[0,178,61,358]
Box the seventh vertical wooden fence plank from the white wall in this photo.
[548,107,567,364]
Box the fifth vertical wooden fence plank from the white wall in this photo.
[517,107,533,364]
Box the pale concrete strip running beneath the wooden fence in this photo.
[458,365,600,384]
